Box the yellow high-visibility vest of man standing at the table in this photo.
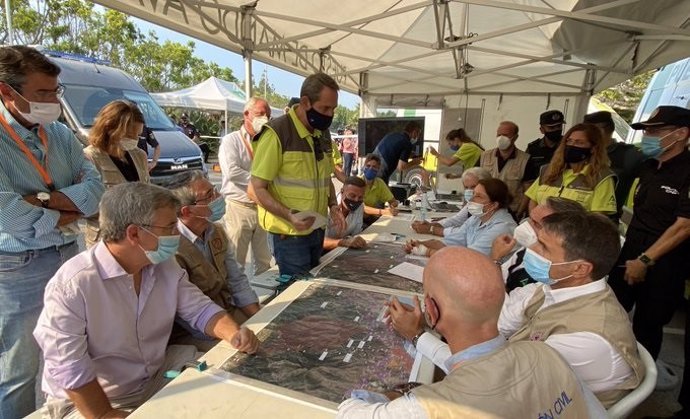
[254,111,333,236]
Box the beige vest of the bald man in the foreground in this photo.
[412,342,588,419]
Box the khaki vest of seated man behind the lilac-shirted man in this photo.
[175,226,235,312]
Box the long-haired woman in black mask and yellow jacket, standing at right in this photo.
[525,124,616,214]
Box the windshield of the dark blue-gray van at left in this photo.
[64,84,177,131]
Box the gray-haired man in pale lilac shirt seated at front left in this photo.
[34,182,259,418]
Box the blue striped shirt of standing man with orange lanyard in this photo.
[0,103,104,253]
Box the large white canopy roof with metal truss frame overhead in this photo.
[97,0,690,103]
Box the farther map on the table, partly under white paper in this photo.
[315,242,426,294]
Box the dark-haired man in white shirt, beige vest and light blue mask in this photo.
[391,211,644,407]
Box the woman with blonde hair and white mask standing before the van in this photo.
[84,100,150,247]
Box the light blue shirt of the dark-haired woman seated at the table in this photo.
[442,208,517,256]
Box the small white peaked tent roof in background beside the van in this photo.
[151,77,245,113]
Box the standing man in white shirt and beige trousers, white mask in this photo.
[218,97,271,275]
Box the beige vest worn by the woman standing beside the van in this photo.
[84,145,151,248]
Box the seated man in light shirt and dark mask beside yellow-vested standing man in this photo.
[323,176,367,251]
